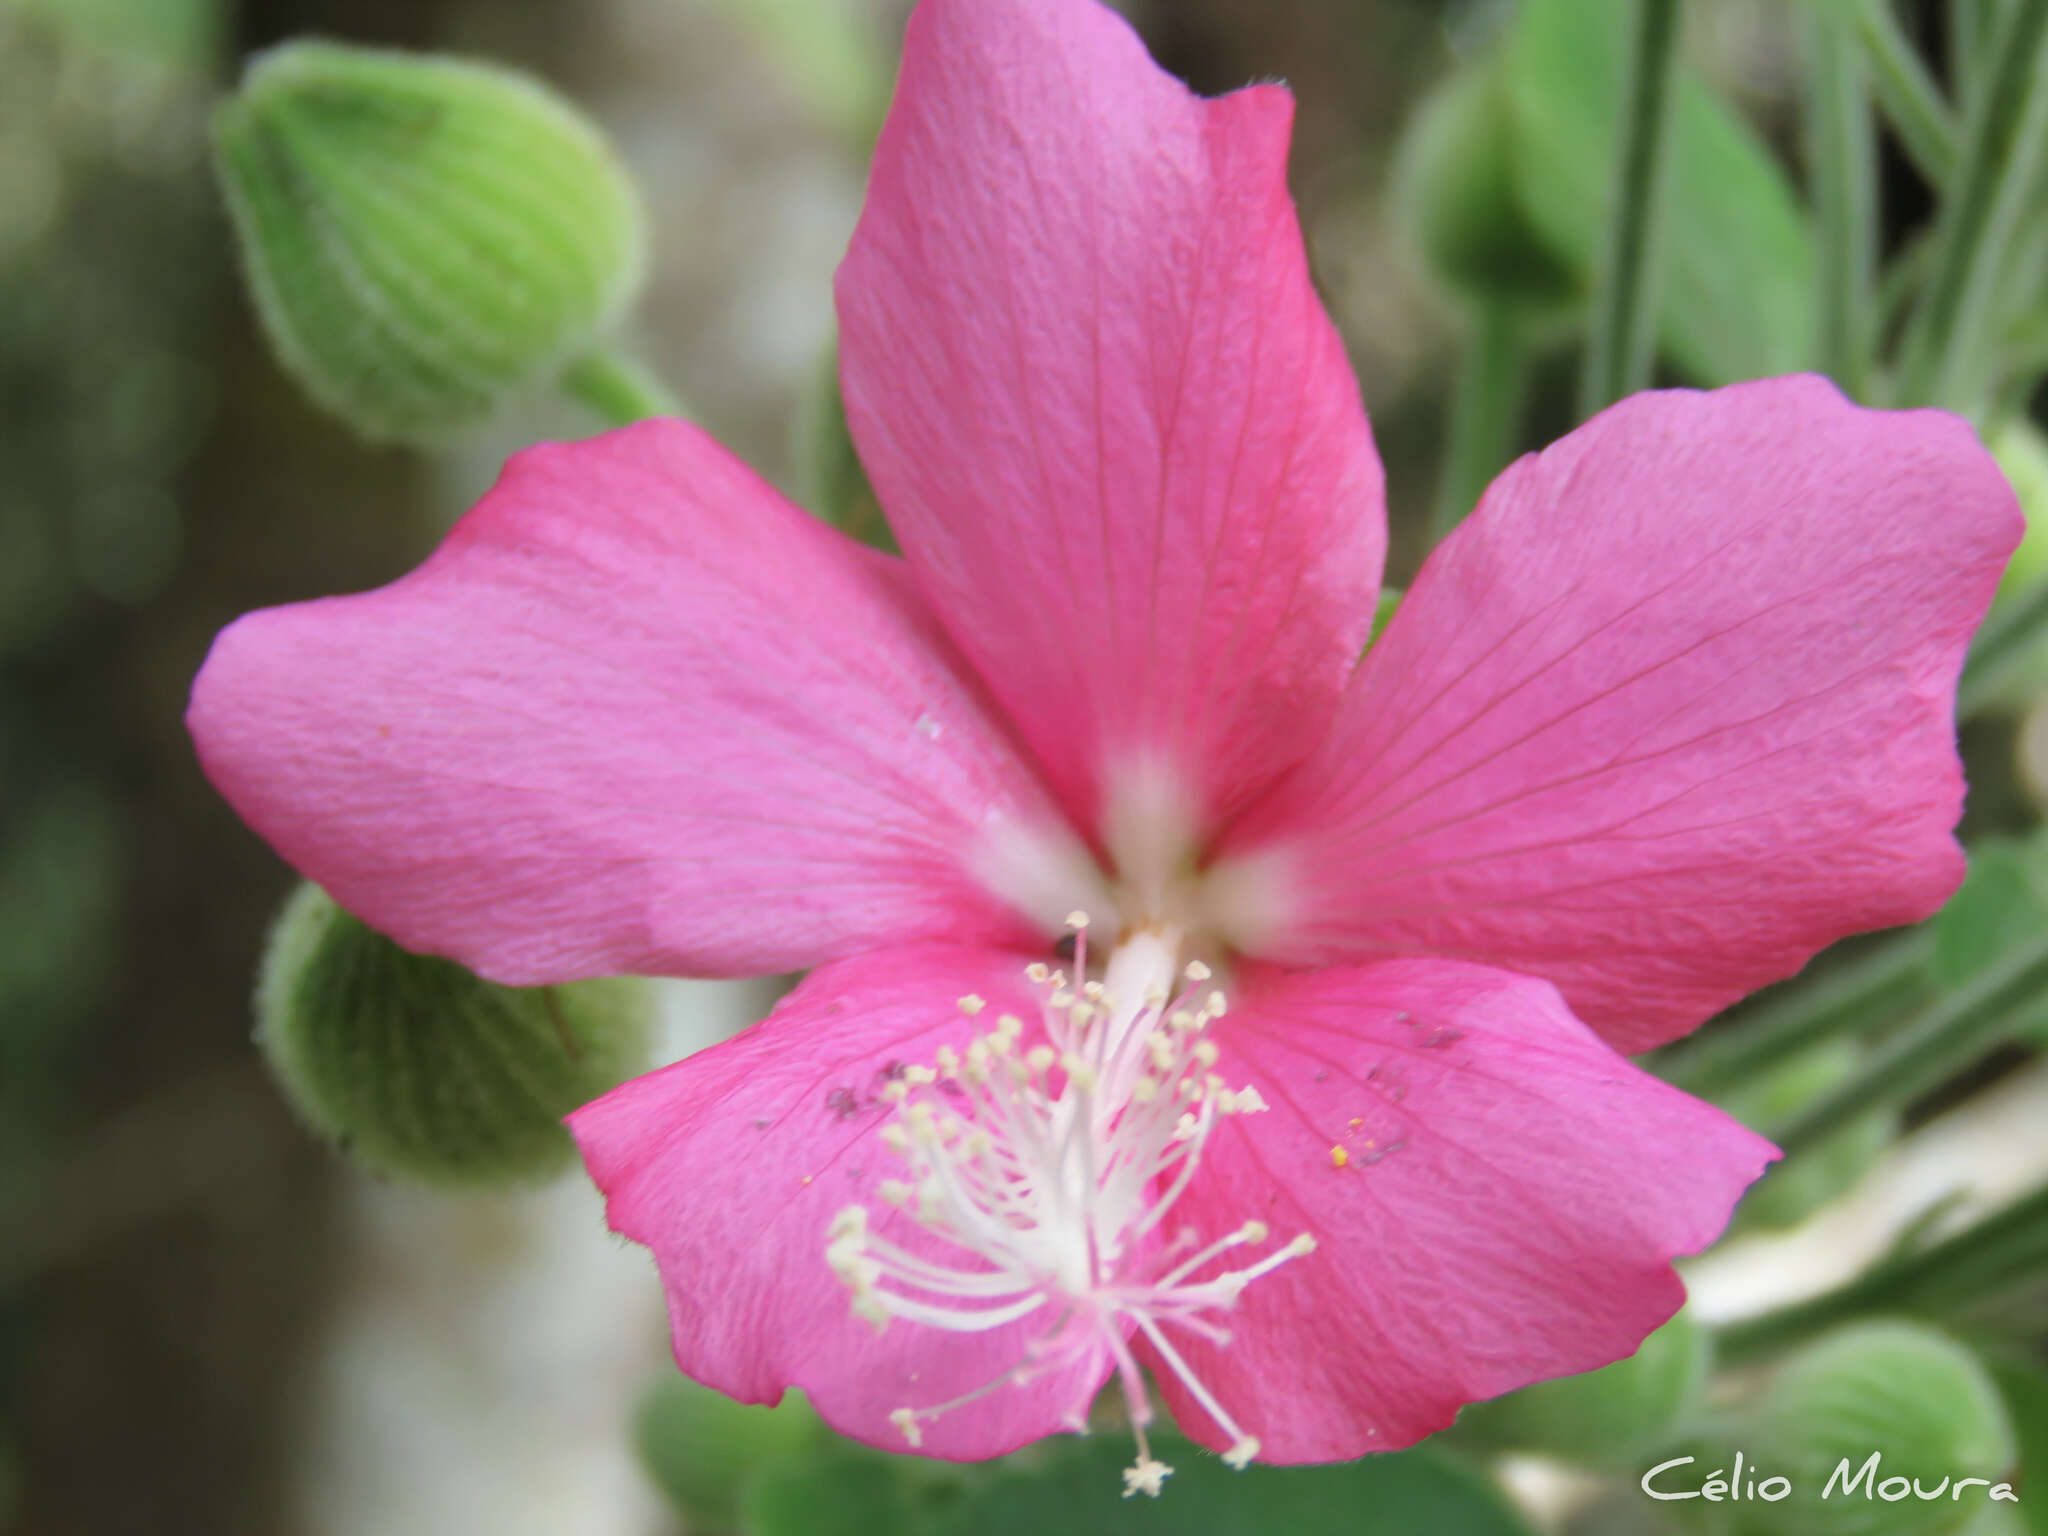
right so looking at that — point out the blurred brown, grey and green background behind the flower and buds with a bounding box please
[0,0,2048,1536]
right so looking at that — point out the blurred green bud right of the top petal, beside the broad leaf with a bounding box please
[1395,68,1583,307]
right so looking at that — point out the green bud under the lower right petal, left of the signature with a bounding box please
[1458,1309,1712,1470]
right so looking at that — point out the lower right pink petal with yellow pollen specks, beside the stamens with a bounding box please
[1153,961,1776,1462]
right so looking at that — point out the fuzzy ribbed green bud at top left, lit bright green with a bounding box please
[213,43,645,442]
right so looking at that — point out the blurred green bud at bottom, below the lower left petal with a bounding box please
[633,1372,831,1530]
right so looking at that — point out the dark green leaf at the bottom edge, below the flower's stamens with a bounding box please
[920,1436,1528,1536]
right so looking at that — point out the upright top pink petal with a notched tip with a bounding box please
[838,0,1384,844]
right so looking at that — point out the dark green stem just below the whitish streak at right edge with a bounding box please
[1714,1188,2048,1364]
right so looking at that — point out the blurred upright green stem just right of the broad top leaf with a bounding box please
[1806,10,1878,399]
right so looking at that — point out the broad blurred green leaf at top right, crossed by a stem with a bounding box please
[1503,0,1815,385]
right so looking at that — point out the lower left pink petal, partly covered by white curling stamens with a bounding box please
[569,948,1110,1460]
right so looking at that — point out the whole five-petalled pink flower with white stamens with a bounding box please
[190,0,2019,1491]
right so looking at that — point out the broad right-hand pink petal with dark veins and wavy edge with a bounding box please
[1231,377,2021,1051]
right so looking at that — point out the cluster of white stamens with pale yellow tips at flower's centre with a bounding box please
[825,913,1315,1497]
